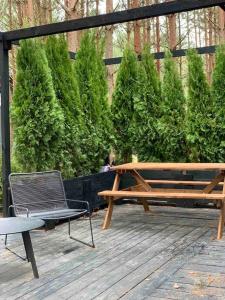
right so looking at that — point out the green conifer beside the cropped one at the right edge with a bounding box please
[186,50,214,162]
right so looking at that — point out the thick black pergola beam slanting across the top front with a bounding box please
[4,0,225,41]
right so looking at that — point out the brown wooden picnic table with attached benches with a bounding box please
[98,162,225,239]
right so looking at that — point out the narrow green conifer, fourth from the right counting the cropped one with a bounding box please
[132,47,163,161]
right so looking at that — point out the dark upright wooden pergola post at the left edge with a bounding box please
[0,35,11,217]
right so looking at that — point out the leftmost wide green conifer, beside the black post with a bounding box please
[11,40,64,172]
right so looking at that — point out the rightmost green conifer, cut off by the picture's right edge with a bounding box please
[212,45,225,162]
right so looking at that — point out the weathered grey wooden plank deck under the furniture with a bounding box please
[0,204,225,300]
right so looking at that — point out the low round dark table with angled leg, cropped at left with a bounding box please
[0,217,45,278]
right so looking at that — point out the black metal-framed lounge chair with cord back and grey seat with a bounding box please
[5,171,95,248]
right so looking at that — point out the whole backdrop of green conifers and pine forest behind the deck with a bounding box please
[0,0,225,178]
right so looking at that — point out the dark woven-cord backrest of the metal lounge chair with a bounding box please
[9,171,68,215]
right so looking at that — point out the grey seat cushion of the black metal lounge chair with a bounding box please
[21,208,87,220]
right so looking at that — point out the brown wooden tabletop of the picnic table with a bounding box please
[111,162,225,171]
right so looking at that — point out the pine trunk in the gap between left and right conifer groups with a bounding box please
[105,0,114,102]
